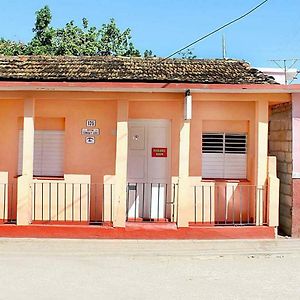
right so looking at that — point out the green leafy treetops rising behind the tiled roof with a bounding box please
[0,6,150,57]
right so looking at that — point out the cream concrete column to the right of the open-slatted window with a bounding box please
[256,99,269,225]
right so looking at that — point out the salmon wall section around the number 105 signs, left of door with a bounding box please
[35,99,117,183]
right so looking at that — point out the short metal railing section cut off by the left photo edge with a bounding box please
[0,183,17,223]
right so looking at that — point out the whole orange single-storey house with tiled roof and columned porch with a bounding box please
[0,56,288,238]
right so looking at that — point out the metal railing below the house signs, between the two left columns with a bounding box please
[31,181,114,224]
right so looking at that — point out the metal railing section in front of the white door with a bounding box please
[126,182,178,222]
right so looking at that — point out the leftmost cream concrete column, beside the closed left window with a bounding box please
[17,99,35,225]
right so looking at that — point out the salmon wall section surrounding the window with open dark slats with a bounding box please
[190,101,256,181]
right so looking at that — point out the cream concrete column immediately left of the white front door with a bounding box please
[113,100,128,227]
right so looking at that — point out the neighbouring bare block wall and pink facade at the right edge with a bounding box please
[269,93,300,237]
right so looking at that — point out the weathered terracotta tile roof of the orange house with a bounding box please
[0,56,275,84]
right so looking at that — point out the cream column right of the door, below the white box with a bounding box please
[177,120,193,227]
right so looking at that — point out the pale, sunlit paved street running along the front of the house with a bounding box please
[0,239,300,300]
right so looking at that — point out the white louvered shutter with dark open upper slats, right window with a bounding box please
[202,133,247,179]
